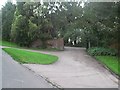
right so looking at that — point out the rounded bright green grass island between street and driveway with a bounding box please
[3,48,58,64]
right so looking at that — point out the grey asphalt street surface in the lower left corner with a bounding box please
[0,49,53,88]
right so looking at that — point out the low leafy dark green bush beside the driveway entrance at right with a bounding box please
[88,47,117,56]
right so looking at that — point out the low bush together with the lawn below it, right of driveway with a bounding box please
[88,47,120,76]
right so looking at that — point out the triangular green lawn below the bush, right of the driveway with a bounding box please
[95,56,120,75]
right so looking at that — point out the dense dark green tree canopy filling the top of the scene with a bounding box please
[2,2,120,48]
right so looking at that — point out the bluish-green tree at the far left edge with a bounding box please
[2,2,15,41]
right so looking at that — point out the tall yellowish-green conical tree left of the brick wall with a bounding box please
[11,2,31,46]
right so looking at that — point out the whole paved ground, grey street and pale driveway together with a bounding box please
[2,47,118,88]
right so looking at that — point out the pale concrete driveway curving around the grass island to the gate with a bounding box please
[24,47,118,88]
